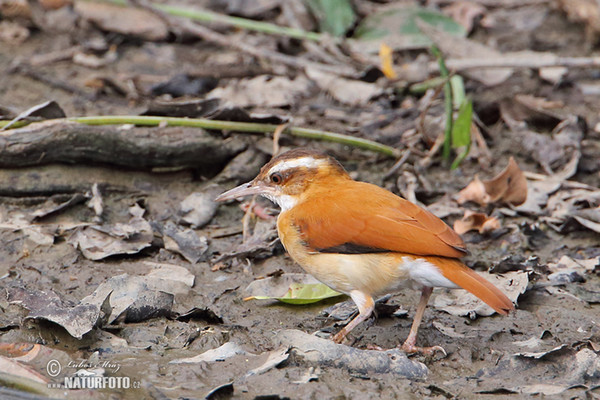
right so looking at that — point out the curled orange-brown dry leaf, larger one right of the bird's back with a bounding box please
[456,157,527,206]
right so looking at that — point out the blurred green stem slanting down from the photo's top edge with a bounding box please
[98,0,322,42]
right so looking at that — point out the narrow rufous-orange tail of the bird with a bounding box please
[428,257,515,315]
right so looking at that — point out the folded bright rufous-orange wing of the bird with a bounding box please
[286,181,467,257]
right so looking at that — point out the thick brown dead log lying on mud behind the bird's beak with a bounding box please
[0,120,246,169]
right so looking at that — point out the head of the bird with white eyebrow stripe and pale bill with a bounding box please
[216,149,351,211]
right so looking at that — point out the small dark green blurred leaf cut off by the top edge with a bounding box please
[307,0,356,37]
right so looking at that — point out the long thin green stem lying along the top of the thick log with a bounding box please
[0,115,400,157]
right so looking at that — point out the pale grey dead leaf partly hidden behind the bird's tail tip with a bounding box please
[433,271,529,317]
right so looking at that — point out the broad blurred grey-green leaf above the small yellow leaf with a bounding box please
[354,6,467,51]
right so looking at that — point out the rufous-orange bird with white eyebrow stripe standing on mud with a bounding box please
[215,148,514,354]
